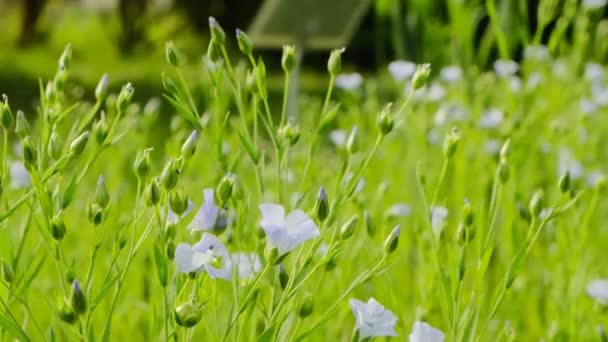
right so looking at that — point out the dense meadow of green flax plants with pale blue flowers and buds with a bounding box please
[0,10,608,342]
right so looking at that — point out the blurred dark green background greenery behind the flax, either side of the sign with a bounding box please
[0,0,608,110]
